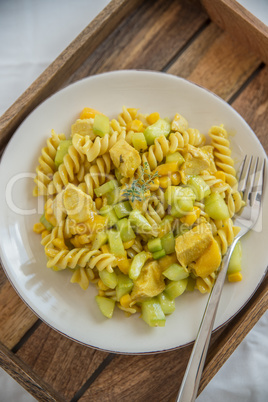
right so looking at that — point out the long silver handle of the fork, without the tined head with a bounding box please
[176,238,238,402]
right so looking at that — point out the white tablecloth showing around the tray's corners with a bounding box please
[0,0,268,402]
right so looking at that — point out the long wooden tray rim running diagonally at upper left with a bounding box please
[0,0,142,153]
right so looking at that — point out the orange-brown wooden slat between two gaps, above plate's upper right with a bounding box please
[168,23,261,101]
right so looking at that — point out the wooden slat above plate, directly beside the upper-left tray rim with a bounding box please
[65,0,208,82]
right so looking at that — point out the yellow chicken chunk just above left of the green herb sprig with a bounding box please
[109,139,141,177]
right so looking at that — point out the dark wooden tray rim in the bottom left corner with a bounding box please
[0,342,64,402]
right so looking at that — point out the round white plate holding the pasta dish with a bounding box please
[0,71,268,353]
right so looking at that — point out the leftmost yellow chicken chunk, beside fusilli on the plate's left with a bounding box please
[63,183,95,223]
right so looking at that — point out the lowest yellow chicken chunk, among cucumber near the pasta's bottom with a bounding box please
[131,261,165,301]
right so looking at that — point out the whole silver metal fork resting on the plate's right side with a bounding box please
[176,156,265,402]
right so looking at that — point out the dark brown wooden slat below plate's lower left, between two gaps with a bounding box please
[16,324,108,400]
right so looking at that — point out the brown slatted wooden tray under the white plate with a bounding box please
[0,0,268,402]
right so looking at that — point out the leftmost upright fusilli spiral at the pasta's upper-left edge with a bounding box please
[33,130,65,196]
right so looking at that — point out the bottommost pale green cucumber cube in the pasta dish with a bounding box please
[141,298,166,327]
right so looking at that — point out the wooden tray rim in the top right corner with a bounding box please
[200,0,268,63]
